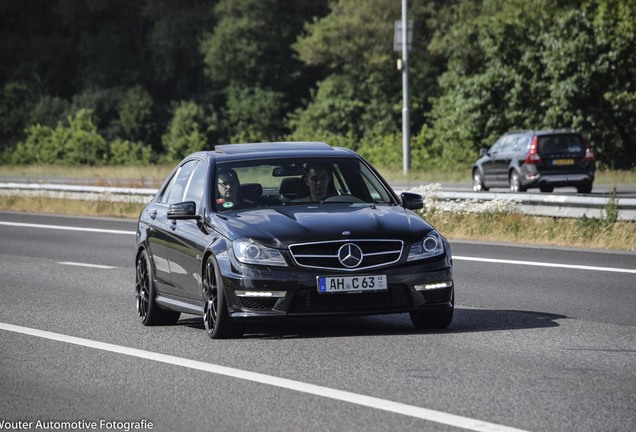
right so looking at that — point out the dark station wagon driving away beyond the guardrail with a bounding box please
[472,130,596,193]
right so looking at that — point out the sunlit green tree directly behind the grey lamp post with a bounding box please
[290,0,444,148]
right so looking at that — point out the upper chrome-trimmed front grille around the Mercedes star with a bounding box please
[289,240,404,271]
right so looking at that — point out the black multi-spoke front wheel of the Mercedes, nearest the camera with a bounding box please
[202,256,243,339]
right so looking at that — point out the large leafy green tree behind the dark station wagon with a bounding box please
[418,0,636,167]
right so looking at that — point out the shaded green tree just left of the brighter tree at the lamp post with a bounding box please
[201,0,326,140]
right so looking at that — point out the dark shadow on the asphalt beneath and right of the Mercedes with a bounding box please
[179,308,567,339]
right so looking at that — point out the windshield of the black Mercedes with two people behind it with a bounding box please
[213,158,396,211]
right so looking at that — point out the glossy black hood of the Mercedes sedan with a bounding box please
[210,204,433,247]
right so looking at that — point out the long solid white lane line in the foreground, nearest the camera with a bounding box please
[0,322,526,432]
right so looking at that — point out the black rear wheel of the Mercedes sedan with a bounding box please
[135,250,181,326]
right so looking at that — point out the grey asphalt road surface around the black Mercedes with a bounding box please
[0,212,636,432]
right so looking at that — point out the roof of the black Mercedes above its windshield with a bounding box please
[191,141,356,161]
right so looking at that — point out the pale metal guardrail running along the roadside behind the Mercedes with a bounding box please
[0,183,636,221]
